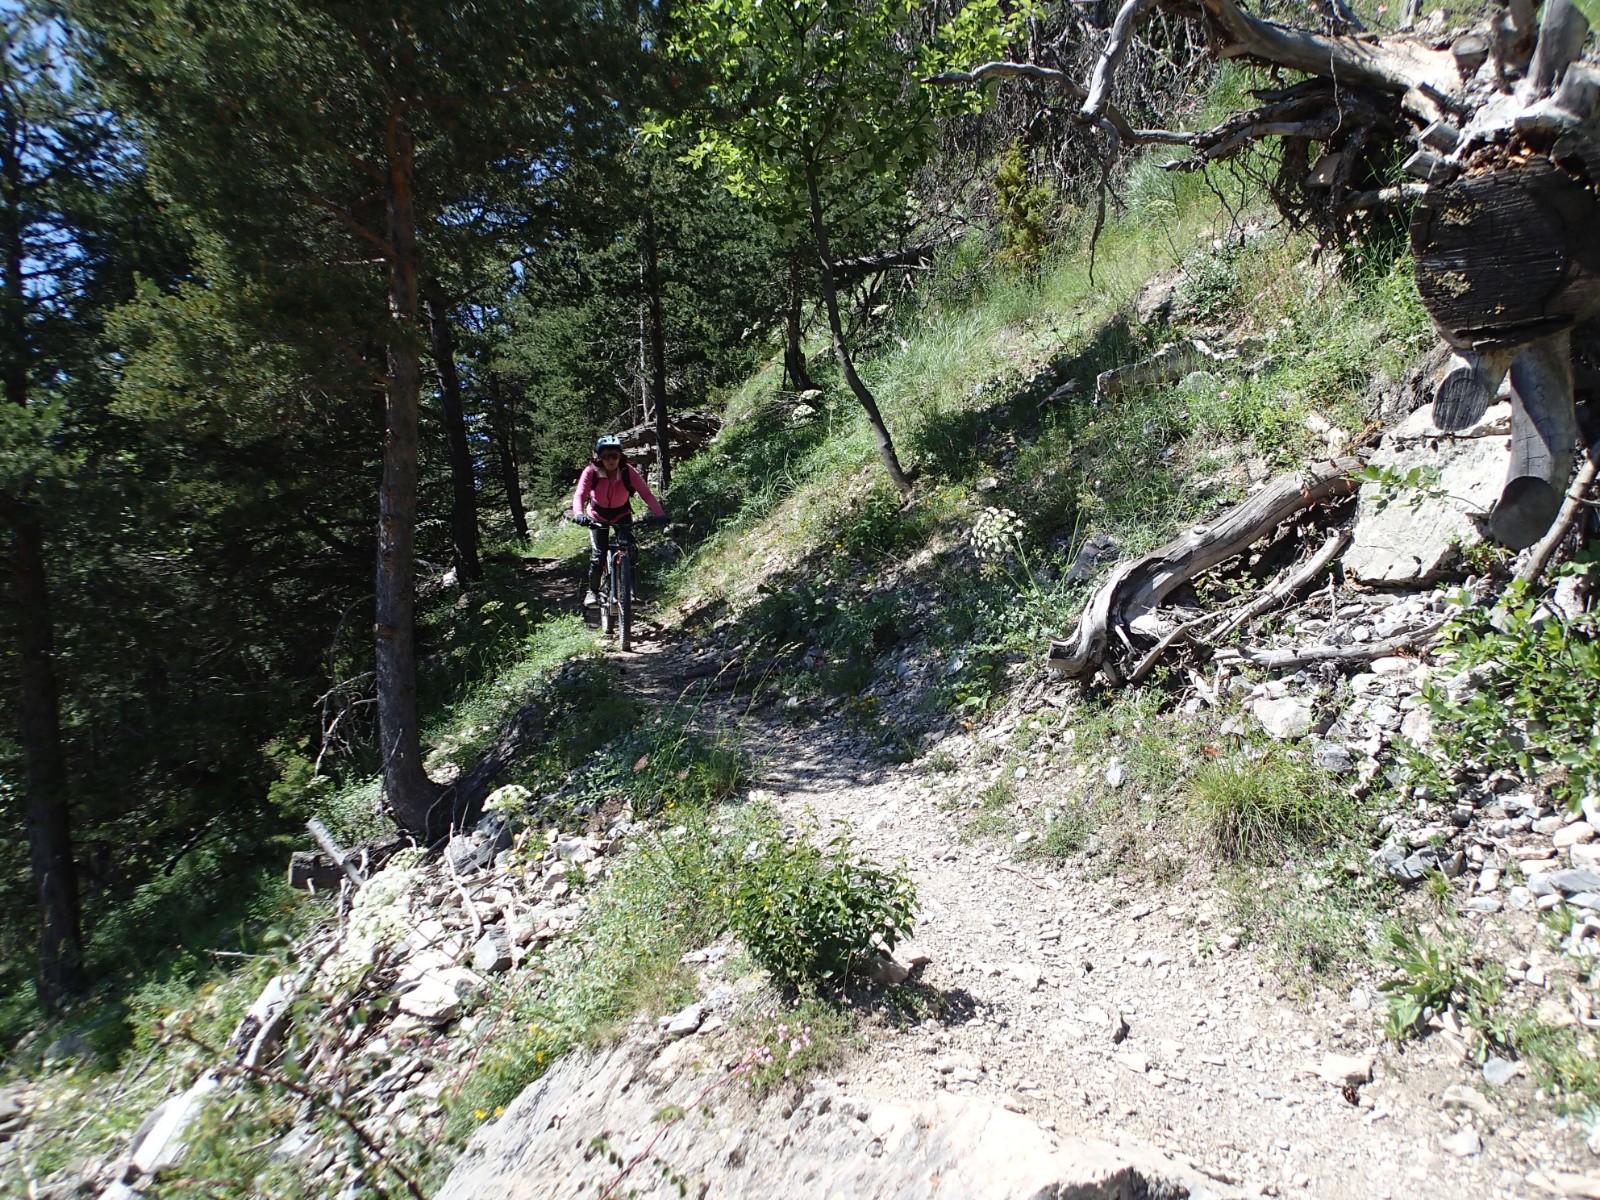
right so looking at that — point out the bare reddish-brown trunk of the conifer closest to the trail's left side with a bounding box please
[376,112,446,842]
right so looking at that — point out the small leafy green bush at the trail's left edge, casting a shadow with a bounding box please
[730,830,917,987]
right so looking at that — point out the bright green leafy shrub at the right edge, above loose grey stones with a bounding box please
[1424,576,1600,805]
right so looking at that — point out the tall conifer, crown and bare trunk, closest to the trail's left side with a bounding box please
[69,0,656,838]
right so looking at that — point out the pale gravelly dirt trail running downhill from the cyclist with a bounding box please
[621,638,1592,1200]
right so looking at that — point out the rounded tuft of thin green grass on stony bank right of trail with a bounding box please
[1184,750,1355,861]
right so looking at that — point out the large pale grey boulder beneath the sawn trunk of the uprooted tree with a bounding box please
[1344,403,1510,584]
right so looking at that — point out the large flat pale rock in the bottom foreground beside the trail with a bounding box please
[435,1038,1234,1200]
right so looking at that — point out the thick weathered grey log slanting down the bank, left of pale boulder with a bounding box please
[1050,458,1362,683]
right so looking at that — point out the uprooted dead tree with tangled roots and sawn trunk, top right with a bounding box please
[934,0,1600,560]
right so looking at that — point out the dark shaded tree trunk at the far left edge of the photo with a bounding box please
[0,103,85,1011]
